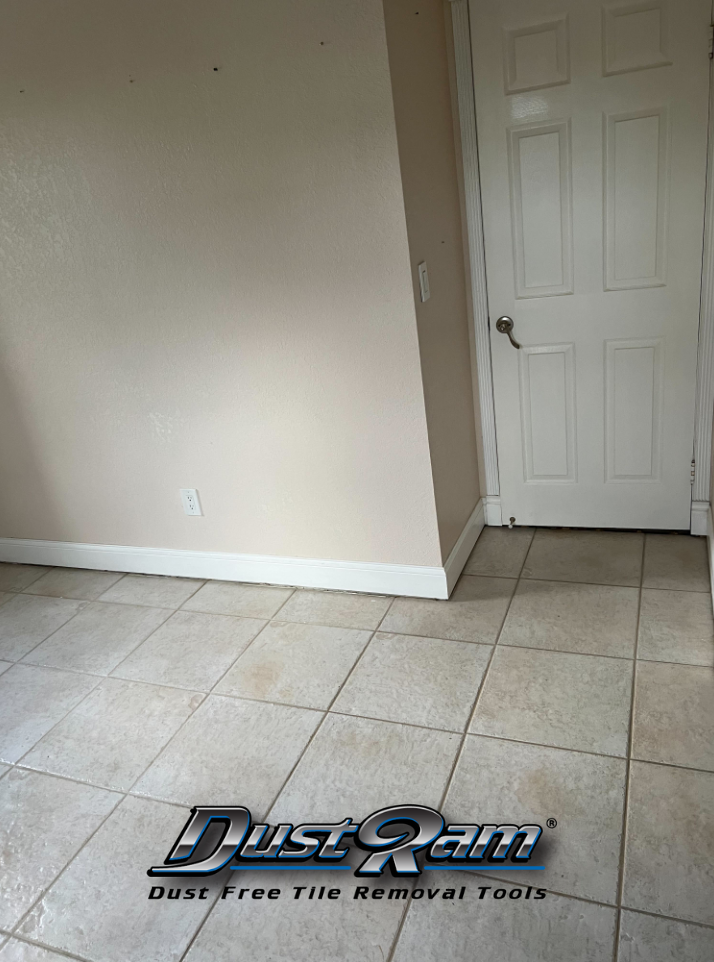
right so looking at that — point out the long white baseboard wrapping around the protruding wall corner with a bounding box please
[0,502,483,598]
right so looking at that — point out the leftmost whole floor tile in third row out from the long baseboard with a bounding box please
[22,678,202,792]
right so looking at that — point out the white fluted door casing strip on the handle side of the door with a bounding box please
[451,0,500,496]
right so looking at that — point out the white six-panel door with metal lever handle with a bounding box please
[471,0,711,529]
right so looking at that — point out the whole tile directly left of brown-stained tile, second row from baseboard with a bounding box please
[112,611,266,691]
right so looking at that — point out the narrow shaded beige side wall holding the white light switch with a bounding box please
[384,0,480,559]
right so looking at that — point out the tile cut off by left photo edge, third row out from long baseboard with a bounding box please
[0,665,99,762]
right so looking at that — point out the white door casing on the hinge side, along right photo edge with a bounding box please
[692,57,714,512]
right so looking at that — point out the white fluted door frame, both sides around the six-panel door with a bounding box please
[450,0,714,535]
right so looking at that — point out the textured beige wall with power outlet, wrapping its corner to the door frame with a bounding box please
[0,0,444,564]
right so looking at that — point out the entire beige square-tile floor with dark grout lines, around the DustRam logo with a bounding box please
[0,528,714,962]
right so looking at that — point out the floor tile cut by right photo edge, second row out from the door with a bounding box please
[637,588,714,666]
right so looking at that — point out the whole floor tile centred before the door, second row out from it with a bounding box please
[500,581,639,658]
